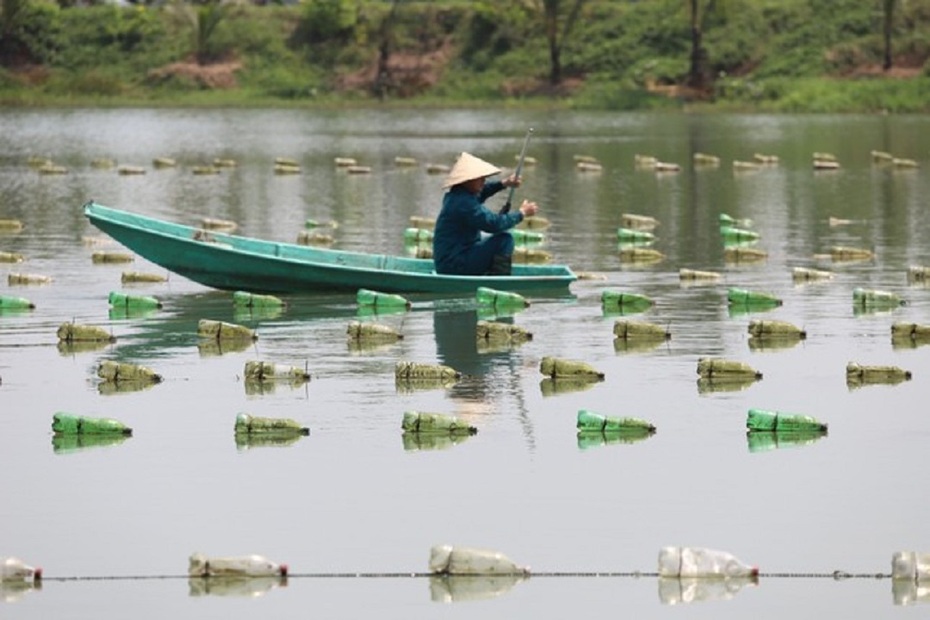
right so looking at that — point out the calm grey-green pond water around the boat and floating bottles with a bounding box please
[0,109,930,619]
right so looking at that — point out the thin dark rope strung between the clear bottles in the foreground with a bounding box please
[36,570,891,582]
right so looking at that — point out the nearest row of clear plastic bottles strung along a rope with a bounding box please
[0,544,930,605]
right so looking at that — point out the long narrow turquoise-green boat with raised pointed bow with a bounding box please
[84,201,577,294]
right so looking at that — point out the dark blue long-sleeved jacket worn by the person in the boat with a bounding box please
[433,181,523,273]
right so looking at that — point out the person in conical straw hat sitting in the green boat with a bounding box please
[433,153,538,275]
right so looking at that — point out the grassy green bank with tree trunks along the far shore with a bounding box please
[0,0,930,113]
